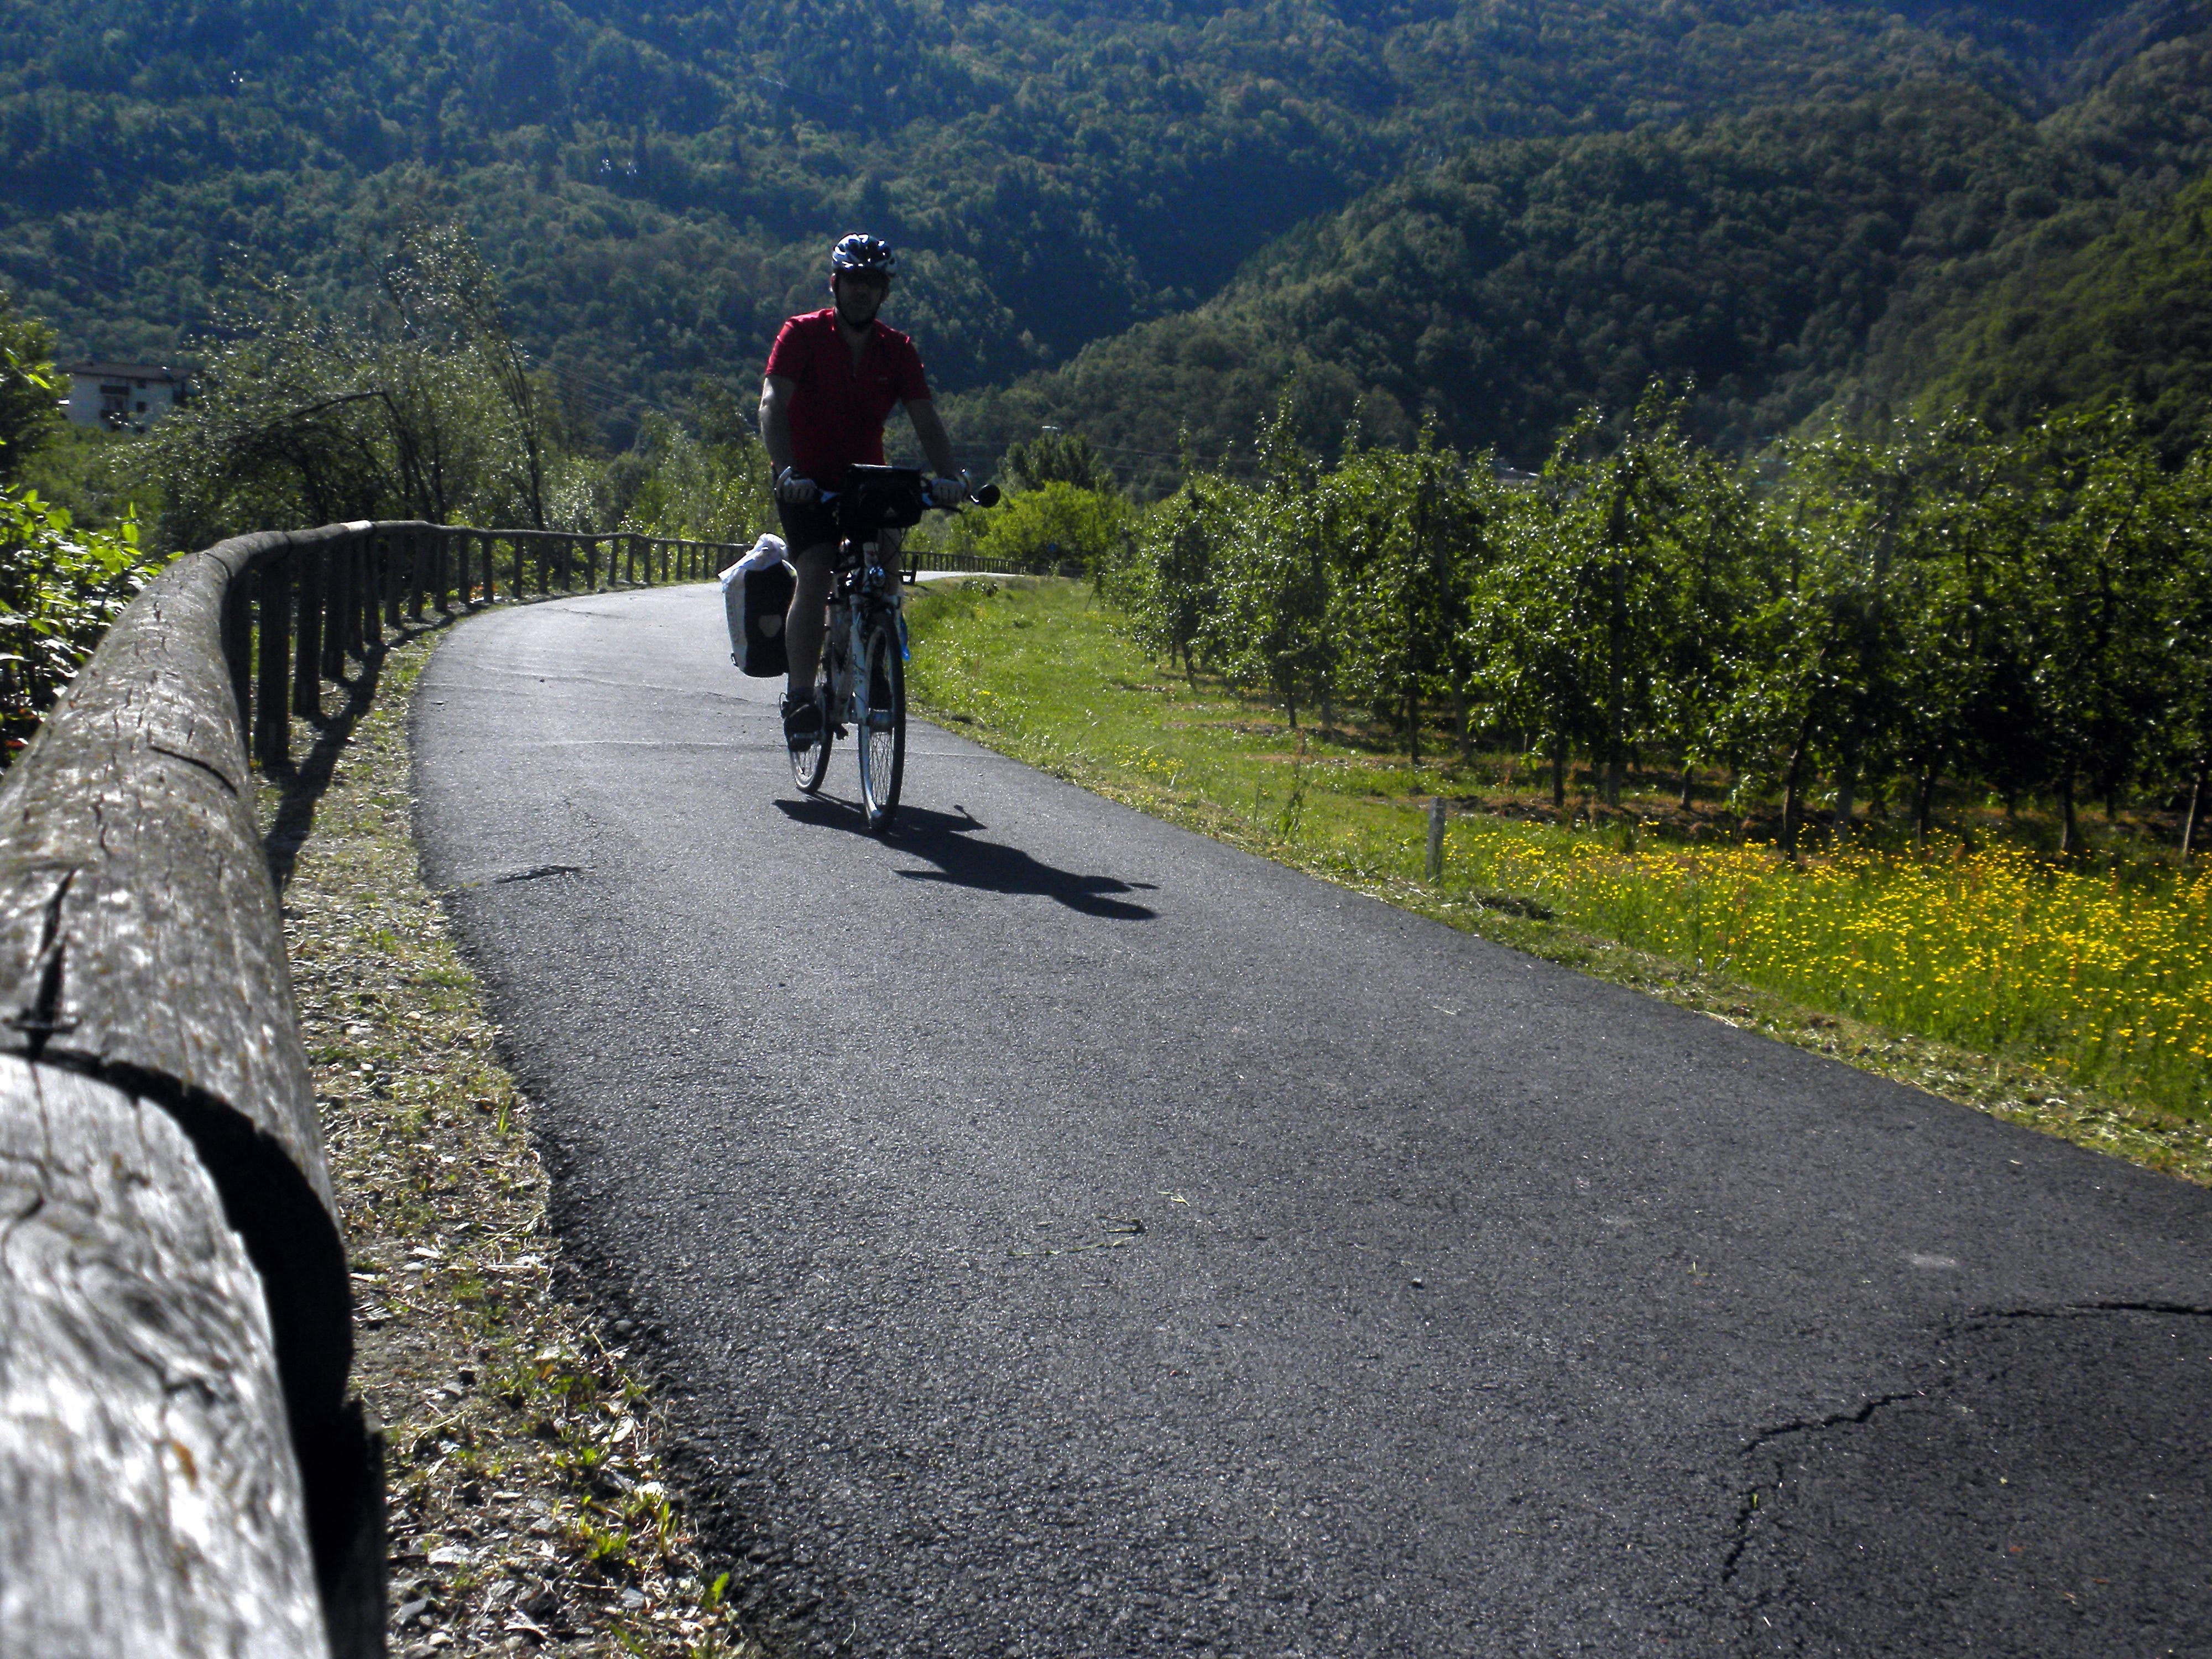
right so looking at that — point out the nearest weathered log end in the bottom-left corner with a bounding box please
[0,1057,325,1659]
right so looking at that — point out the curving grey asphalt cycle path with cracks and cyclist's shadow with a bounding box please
[416,586,2212,1659]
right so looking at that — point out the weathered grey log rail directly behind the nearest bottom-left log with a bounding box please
[0,526,383,1655]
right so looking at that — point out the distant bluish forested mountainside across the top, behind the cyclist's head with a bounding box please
[0,0,2192,447]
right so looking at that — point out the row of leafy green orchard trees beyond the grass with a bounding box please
[1102,387,2212,847]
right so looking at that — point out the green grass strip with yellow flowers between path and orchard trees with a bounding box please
[909,580,2212,1181]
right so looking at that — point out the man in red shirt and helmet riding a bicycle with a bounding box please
[761,232,967,748]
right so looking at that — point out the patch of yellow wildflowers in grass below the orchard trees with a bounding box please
[1447,821,2212,1113]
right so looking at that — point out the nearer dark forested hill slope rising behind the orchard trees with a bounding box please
[967,13,2212,487]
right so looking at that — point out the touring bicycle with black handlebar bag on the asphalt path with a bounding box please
[792,467,998,834]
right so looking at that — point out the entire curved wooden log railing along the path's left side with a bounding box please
[0,522,741,1659]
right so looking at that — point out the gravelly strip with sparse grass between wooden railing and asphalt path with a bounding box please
[261,633,763,1659]
